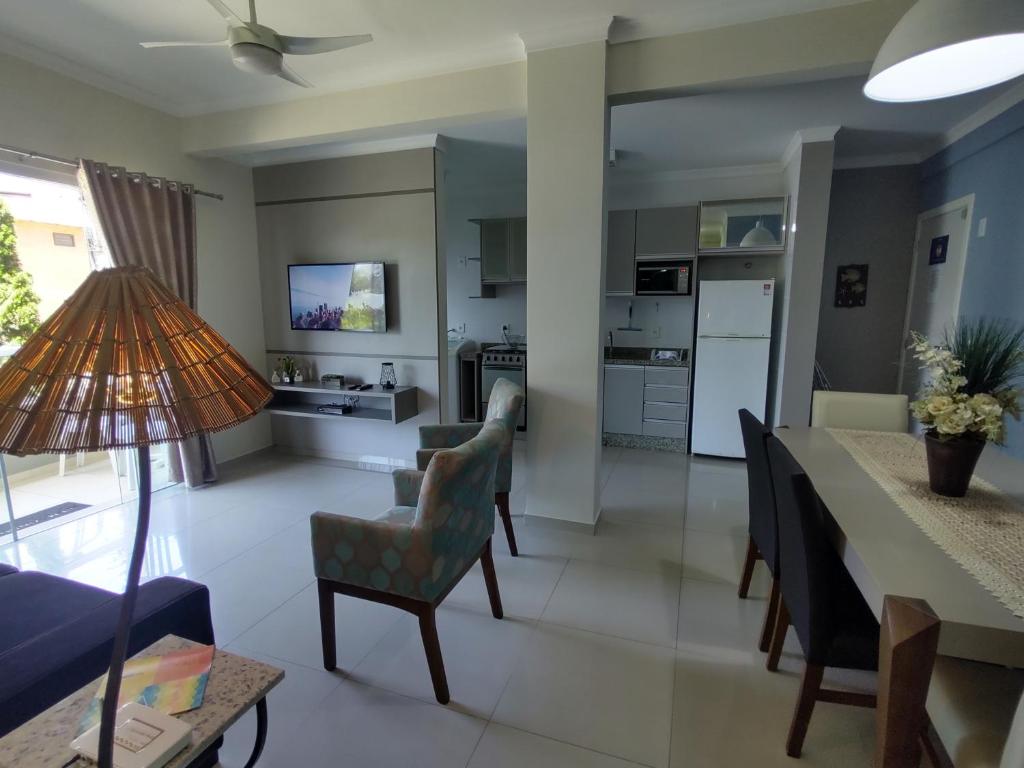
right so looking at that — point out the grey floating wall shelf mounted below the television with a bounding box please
[266,384,419,424]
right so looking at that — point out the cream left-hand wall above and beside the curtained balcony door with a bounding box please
[0,54,270,472]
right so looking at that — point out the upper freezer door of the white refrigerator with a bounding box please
[697,280,775,338]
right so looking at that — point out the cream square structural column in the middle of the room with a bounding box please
[526,36,608,525]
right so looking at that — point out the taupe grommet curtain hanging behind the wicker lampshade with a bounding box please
[79,160,217,487]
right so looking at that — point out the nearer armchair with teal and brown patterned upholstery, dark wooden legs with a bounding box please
[310,420,508,703]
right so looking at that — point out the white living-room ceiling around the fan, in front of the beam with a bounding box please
[0,0,859,115]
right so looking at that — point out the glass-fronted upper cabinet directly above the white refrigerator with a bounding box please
[699,198,786,254]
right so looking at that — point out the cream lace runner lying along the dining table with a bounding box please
[827,429,1024,618]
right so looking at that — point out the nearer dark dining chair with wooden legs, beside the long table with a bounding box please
[768,436,881,758]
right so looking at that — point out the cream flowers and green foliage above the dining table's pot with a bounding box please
[910,318,1024,443]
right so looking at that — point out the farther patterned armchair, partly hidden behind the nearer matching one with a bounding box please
[416,379,526,557]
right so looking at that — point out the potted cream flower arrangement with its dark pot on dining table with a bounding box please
[910,319,1024,498]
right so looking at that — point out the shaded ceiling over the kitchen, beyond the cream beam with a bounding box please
[430,78,1021,181]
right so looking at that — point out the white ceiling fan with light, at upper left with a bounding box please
[140,0,374,88]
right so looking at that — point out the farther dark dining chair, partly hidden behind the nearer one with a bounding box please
[739,409,779,651]
